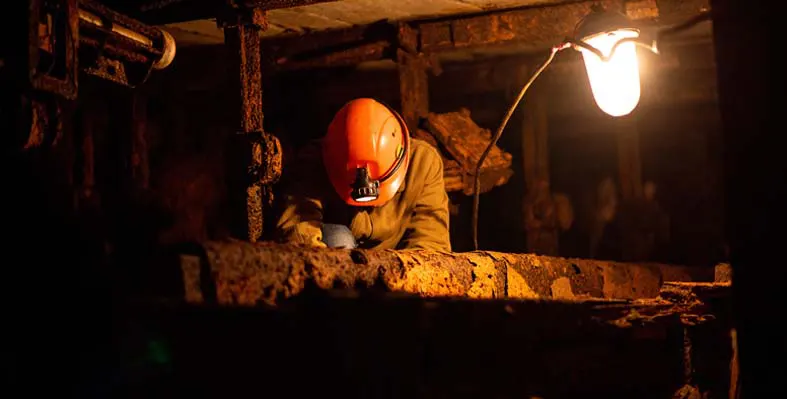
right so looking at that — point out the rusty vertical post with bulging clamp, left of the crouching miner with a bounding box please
[219,9,281,242]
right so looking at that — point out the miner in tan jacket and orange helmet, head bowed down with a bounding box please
[277,98,451,252]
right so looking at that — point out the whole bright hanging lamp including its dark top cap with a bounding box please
[577,10,640,117]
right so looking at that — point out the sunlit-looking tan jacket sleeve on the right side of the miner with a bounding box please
[399,148,451,252]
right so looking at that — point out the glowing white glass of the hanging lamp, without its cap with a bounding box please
[580,29,640,117]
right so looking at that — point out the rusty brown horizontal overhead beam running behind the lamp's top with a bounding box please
[265,0,708,69]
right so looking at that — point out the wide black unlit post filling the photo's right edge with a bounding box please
[711,0,787,398]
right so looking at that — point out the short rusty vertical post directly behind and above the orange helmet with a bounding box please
[396,23,429,134]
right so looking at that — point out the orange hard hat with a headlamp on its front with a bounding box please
[322,98,410,206]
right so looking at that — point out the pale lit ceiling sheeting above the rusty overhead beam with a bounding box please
[167,0,567,45]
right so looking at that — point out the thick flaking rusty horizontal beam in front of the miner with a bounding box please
[181,241,714,305]
